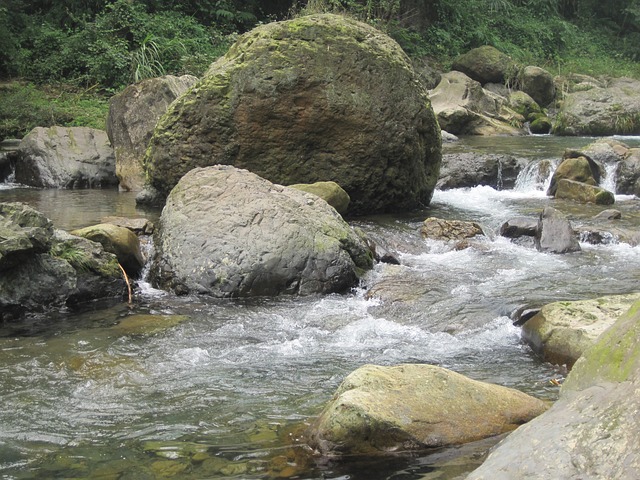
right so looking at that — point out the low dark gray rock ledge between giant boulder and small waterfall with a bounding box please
[436,152,527,190]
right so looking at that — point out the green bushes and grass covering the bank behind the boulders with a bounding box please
[0,0,640,139]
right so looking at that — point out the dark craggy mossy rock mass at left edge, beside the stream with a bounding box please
[0,203,124,321]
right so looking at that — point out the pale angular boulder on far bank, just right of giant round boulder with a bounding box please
[429,71,524,135]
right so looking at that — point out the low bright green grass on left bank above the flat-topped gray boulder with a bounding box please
[0,82,109,140]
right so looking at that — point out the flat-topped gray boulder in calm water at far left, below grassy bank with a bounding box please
[15,127,118,188]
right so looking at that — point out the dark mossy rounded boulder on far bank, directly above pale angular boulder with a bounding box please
[451,45,516,85]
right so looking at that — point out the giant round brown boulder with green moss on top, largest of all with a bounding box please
[145,14,441,214]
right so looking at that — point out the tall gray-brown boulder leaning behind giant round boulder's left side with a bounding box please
[107,75,198,191]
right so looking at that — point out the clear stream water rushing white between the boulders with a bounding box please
[0,137,640,480]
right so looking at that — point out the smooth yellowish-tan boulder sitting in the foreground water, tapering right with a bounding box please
[306,364,547,454]
